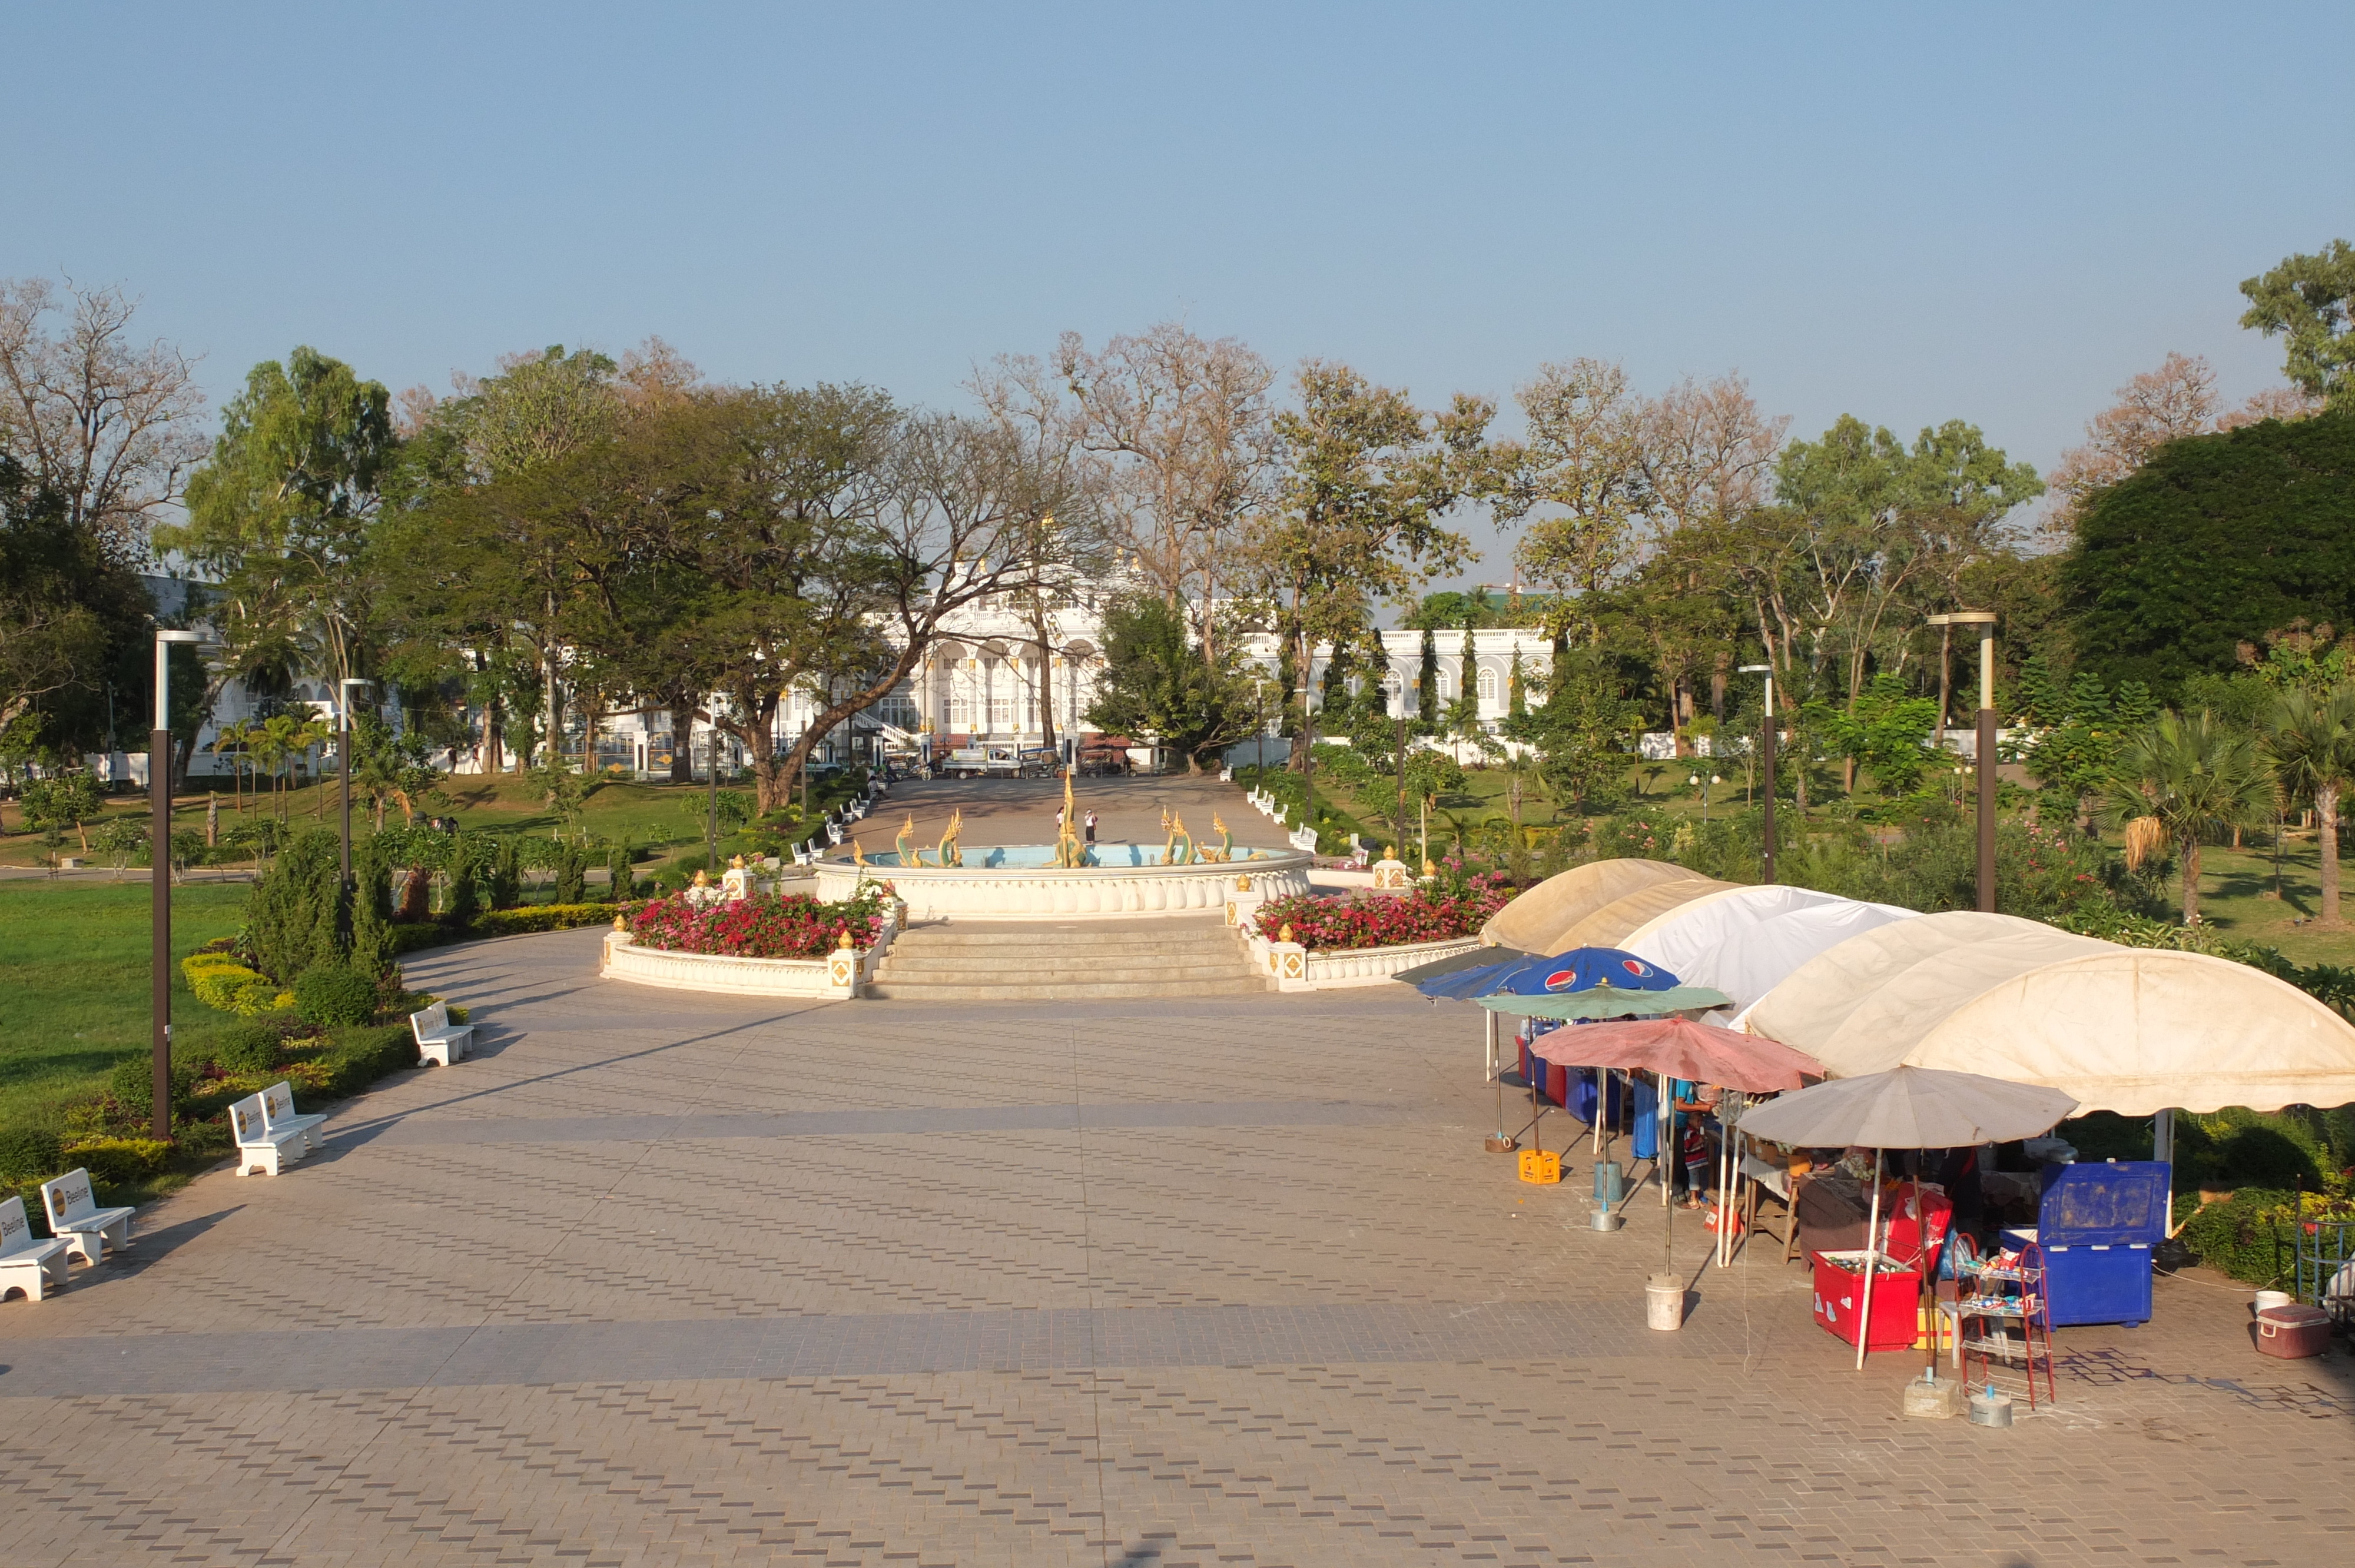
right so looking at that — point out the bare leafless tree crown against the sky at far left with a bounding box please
[0,278,210,553]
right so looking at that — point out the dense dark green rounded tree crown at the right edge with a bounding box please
[2061,412,2355,697]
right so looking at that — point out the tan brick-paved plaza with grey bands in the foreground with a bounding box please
[0,923,2355,1568]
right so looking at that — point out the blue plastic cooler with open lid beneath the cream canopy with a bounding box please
[2004,1161,2171,1328]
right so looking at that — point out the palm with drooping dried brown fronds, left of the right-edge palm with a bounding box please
[2105,709,2273,925]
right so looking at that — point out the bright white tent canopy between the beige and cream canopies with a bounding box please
[1618,883,1922,1008]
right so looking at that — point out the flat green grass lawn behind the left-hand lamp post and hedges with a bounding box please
[0,881,245,1125]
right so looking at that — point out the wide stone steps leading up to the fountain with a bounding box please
[867,918,1276,1001]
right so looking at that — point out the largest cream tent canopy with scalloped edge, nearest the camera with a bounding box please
[1743,911,2355,1116]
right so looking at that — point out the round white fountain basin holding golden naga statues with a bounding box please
[812,843,1309,921]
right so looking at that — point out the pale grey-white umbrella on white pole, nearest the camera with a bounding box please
[1740,1067,2077,1370]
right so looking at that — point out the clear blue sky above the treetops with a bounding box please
[0,0,2355,572]
